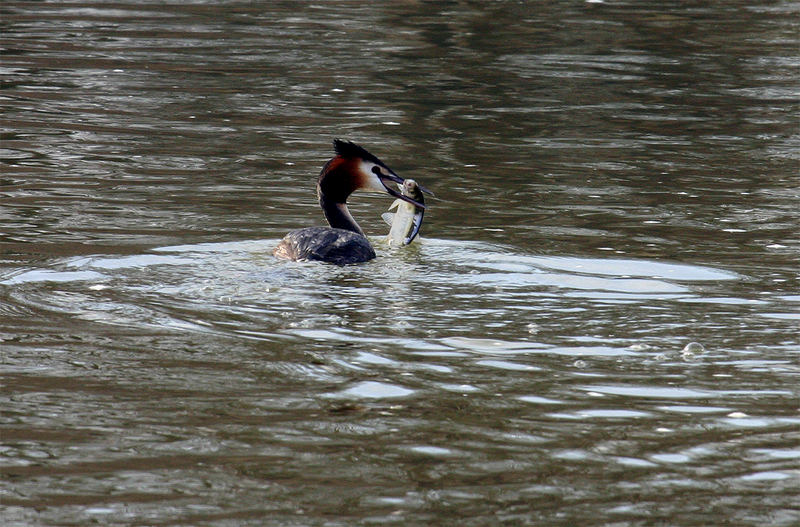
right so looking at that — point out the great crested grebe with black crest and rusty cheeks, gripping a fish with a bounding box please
[273,139,425,265]
